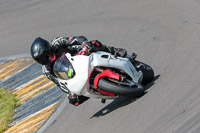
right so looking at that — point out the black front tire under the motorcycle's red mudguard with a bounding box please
[98,78,145,97]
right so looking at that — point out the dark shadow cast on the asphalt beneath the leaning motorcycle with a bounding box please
[90,75,160,119]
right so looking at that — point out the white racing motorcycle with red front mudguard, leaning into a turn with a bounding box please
[53,51,154,103]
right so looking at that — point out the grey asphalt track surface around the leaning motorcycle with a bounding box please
[0,0,200,133]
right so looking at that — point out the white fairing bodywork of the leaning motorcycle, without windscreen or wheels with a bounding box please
[54,51,142,99]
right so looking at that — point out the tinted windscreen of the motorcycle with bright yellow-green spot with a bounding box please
[53,55,75,80]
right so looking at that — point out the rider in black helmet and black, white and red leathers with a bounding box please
[30,36,127,106]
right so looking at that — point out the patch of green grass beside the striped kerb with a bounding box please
[0,89,17,133]
